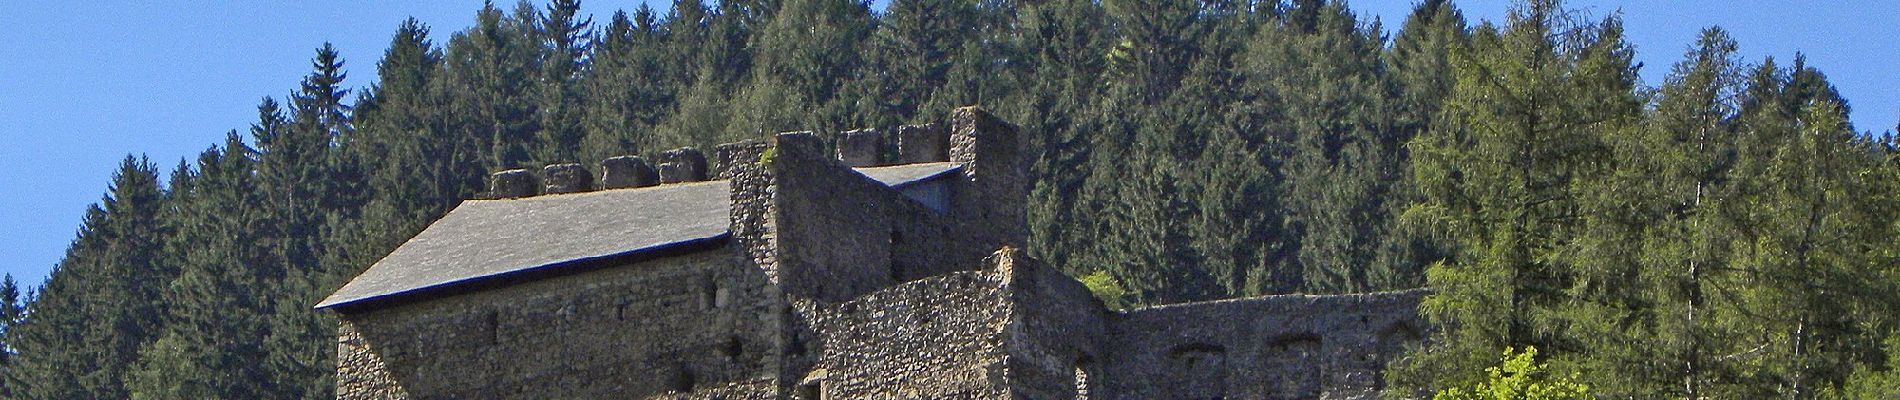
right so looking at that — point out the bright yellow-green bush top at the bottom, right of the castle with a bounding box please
[1431,347,1594,400]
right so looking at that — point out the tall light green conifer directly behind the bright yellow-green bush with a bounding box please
[1398,0,1640,385]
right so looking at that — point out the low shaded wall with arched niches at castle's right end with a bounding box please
[1106,290,1425,400]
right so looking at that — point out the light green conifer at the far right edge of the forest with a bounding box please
[1725,59,1900,398]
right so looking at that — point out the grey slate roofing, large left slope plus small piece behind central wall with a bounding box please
[317,163,958,309]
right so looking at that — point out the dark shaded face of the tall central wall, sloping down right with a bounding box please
[763,133,1020,303]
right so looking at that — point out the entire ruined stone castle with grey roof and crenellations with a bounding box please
[317,108,1425,400]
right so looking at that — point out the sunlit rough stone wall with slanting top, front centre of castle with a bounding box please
[798,271,1009,398]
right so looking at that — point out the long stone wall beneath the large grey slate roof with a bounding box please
[336,250,781,398]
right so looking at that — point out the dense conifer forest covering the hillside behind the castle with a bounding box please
[0,0,1900,398]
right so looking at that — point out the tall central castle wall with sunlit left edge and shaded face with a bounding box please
[718,127,1033,394]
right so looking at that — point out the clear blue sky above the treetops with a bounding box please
[0,0,1900,284]
